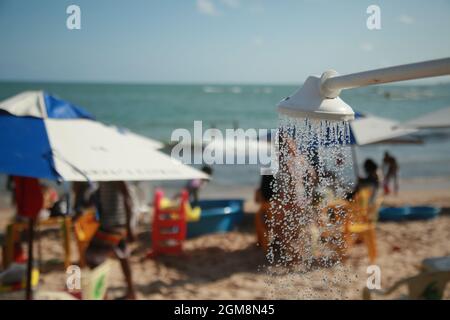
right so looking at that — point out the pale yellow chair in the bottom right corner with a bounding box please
[363,271,450,300]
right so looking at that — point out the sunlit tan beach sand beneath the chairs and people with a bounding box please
[0,181,450,299]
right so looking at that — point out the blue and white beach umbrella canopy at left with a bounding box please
[0,91,207,181]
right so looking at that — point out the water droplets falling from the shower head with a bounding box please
[267,116,352,299]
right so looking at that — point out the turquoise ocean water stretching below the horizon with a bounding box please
[0,82,450,192]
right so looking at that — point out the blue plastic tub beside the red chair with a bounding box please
[187,199,244,238]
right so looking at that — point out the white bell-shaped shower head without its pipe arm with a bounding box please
[278,70,355,121]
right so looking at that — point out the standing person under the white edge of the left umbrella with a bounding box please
[86,181,136,300]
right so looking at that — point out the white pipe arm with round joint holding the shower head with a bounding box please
[320,58,450,98]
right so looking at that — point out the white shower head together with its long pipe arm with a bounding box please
[278,58,450,121]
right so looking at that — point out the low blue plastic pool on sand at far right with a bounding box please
[379,206,441,221]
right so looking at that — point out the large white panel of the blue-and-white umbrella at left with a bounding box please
[46,119,207,181]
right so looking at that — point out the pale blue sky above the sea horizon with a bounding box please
[0,0,450,83]
